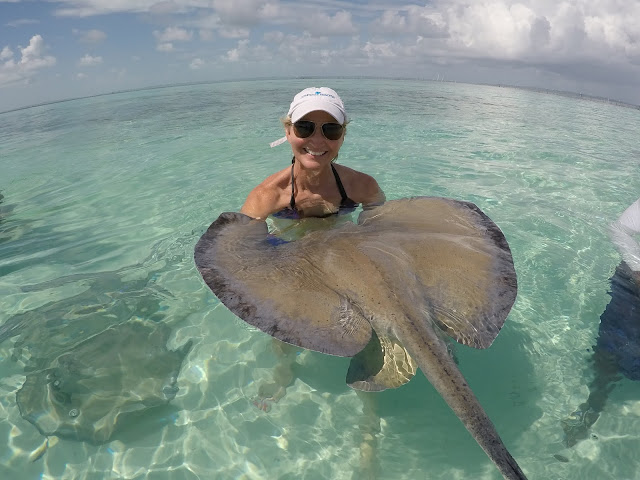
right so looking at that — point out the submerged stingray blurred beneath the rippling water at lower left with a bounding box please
[16,320,191,444]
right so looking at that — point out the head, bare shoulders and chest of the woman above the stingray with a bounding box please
[240,87,385,219]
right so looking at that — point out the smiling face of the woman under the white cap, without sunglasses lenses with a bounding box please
[286,110,344,169]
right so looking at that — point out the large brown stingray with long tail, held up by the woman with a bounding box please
[195,197,526,479]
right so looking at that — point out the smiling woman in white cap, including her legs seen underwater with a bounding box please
[240,87,385,478]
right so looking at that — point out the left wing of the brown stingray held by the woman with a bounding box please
[195,212,371,357]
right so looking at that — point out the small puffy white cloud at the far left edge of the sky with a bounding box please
[0,35,56,86]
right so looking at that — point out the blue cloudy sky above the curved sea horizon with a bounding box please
[0,0,640,112]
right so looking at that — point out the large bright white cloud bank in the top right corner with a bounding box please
[436,0,640,62]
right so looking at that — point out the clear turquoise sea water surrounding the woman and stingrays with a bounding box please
[0,79,640,480]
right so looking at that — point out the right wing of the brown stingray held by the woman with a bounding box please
[358,197,517,348]
